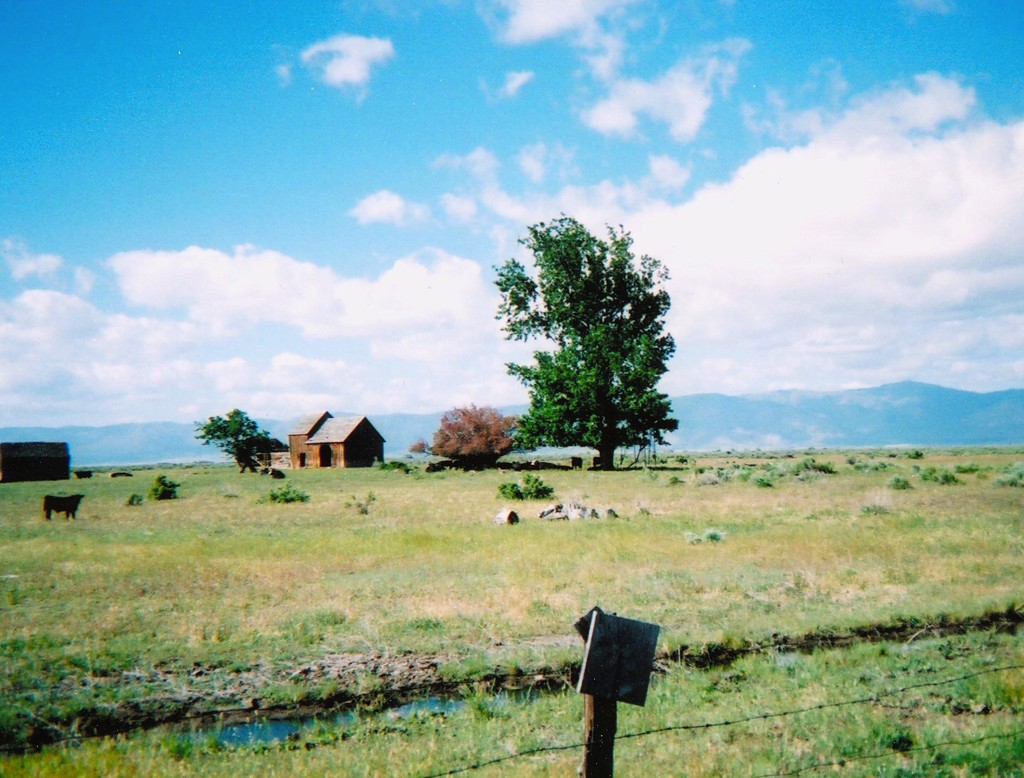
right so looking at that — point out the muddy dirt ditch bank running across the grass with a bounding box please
[9,607,1024,750]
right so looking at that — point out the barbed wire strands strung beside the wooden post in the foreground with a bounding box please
[420,664,1024,778]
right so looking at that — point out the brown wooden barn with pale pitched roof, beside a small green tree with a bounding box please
[288,410,384,468]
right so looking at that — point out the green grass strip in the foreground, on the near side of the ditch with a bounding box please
[4,633,1024,778]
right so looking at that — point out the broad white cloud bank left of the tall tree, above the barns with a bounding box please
[0,247,522,425]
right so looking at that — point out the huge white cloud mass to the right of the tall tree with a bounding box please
[626,76,1024,391]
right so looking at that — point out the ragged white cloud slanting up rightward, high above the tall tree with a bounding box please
[582,39,751,142]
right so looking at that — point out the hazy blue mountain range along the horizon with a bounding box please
[0,382,1024,467]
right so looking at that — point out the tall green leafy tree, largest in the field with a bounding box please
[496,216,679,470]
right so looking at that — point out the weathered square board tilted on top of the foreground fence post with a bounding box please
[575,607,660,705]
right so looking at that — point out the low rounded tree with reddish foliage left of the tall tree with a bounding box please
[430,405,516,467]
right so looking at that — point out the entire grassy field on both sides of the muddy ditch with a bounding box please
[0,449,1024,775]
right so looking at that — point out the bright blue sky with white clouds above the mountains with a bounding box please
[0,0,1024,426]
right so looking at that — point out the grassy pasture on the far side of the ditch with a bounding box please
[0,449,1024,774]
